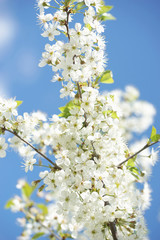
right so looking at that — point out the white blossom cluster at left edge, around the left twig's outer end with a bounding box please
[0,95,46,172]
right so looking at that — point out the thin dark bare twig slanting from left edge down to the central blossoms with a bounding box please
[4,128,61,170]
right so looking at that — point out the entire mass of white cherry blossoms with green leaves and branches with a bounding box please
[0,0,159,240]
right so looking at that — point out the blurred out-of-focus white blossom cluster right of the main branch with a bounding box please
[104,86,156,140]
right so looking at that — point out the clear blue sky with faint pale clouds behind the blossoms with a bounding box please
[0,0,160,240]
